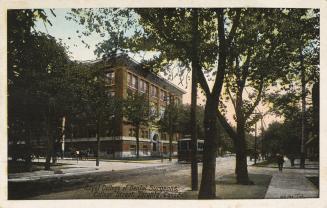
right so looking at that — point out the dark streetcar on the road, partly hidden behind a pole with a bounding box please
[177,138,204,162]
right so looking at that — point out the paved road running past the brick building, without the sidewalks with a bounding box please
[19,157,241,199]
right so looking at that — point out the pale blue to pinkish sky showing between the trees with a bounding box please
[35,9,281,132]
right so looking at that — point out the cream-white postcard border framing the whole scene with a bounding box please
[0,0,327,208]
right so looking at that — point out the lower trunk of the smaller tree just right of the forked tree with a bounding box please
[235,124,253,185]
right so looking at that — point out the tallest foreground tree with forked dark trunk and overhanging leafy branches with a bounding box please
[68,9,239,198]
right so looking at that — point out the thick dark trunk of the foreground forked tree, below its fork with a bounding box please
[199,97,218,199]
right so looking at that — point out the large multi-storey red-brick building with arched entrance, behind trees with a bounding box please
[62,56,185,158]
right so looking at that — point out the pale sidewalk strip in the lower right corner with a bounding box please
[265,160,319,199]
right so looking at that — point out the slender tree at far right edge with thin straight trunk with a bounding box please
[266,9,320,168]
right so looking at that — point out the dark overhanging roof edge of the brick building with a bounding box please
[82,54,186,95]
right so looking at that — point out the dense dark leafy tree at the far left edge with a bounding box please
[8,9,69,169]
